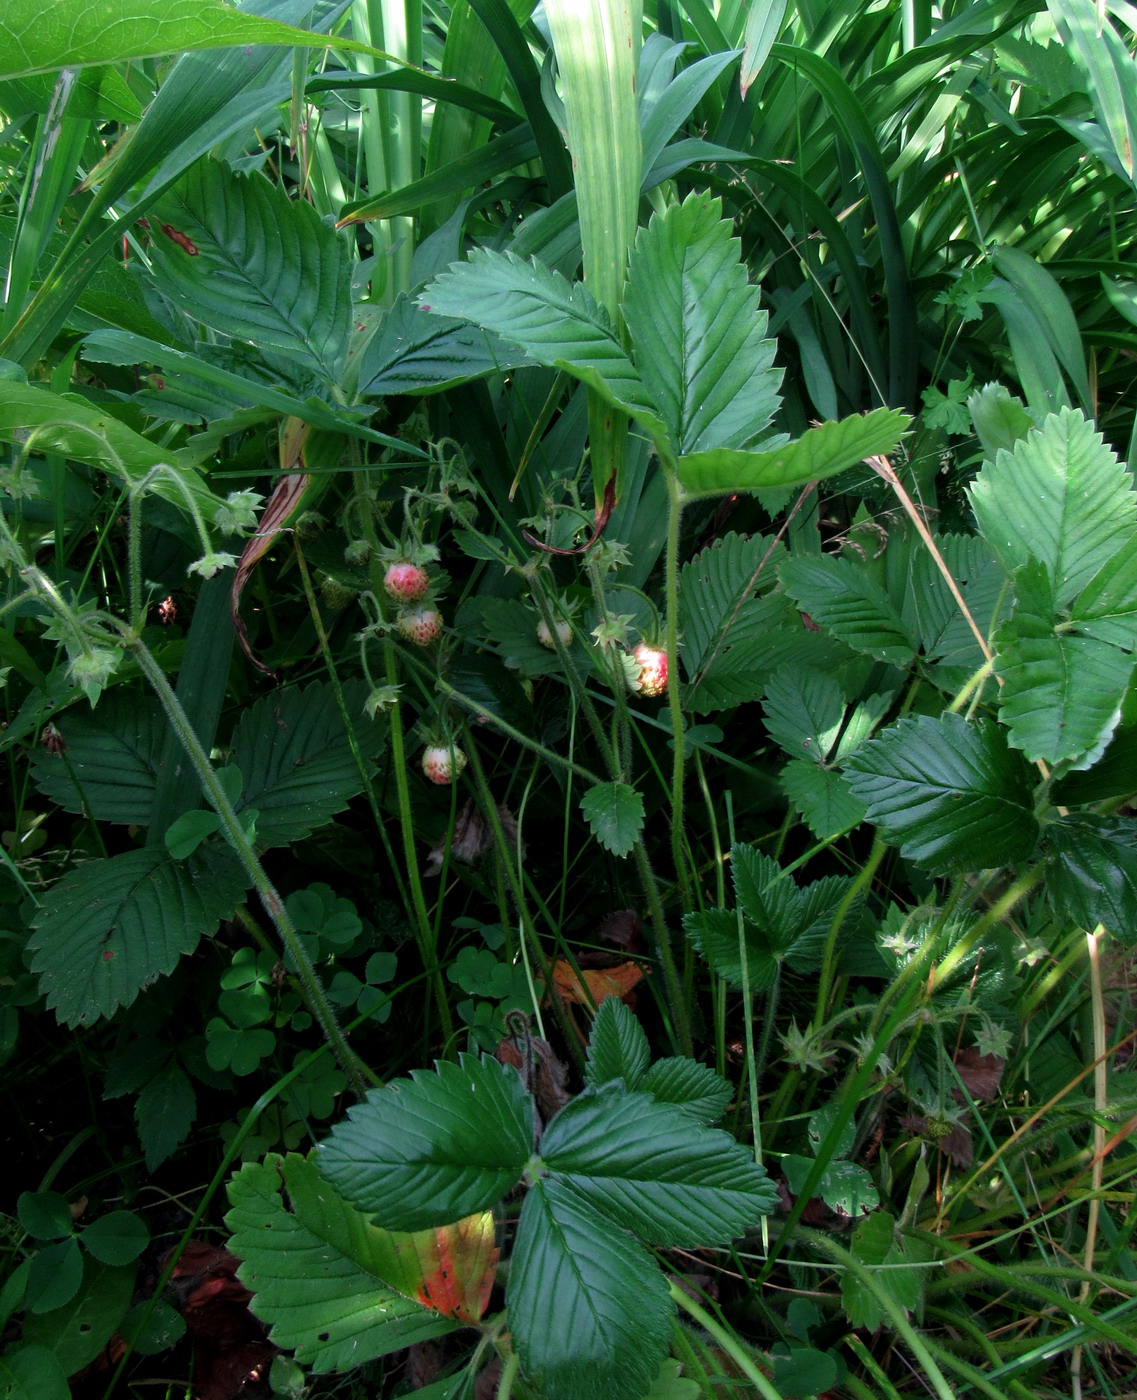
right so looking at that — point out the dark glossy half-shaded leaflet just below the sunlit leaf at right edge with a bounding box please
[846,714,1038,874]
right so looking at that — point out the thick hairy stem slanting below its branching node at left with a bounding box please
[126,636,378,1098]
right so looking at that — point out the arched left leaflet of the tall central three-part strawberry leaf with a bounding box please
[420,248,665,434]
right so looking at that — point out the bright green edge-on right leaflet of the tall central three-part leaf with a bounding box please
[678,409,910,498]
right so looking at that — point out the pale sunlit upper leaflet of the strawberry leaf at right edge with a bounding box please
[970,409,1137,606]
